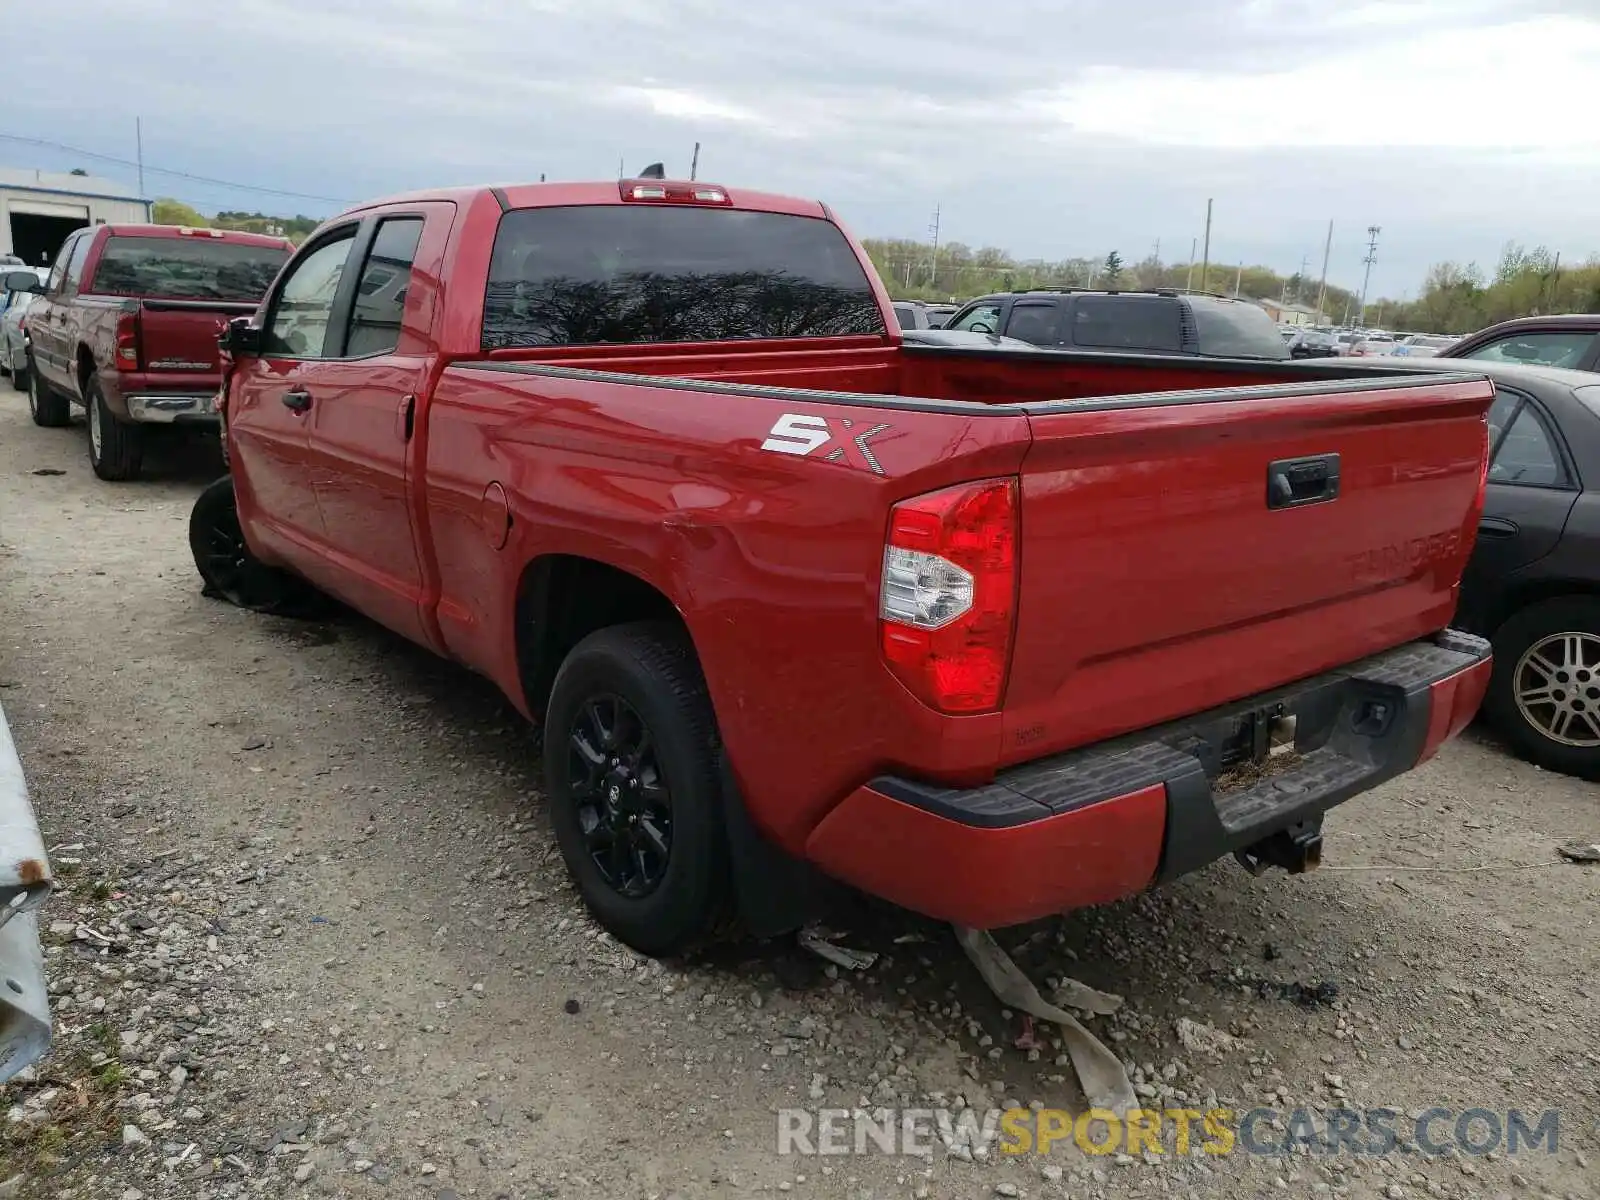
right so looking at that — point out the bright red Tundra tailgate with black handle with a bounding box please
[1003,374,1493,762]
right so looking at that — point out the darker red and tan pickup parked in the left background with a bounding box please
[24,226,294,480]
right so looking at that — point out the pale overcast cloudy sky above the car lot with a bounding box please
[0,0,1600,296]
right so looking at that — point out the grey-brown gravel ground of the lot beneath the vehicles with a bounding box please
[0,392,1600,1200]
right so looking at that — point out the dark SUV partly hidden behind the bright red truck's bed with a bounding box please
[944,288,1290,358]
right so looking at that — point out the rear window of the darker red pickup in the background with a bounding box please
[90,237,290,301]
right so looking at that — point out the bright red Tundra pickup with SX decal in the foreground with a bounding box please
[190,179,1493,954]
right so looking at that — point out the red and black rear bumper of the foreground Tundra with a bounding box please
[806,630,1491,928]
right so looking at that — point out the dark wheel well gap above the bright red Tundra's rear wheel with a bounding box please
[517,554,682,715]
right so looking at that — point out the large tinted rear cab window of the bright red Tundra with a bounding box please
[483,205,886,350]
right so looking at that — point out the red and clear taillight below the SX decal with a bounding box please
[878,478,1018,712]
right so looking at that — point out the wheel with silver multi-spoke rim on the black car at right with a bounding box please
[1485,595,1600,781]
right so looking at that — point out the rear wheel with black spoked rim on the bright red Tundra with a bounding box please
[544,622,728,957]
